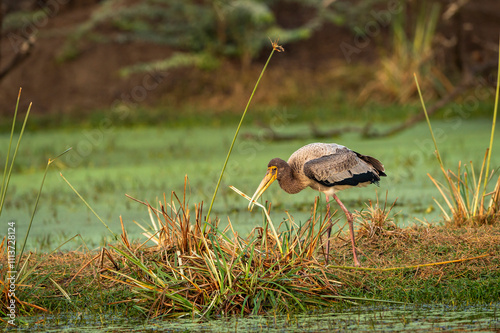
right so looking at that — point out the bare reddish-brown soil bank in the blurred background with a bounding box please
[0,0,500,116]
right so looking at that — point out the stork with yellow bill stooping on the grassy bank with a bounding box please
[248,143,386,266]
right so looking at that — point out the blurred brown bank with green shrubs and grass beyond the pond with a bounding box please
[0,0,500,128]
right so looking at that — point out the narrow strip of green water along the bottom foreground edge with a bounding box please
[10,303,500,333]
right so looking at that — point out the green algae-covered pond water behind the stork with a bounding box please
[0,119,500,251]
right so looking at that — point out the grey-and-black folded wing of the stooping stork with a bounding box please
[303,148,385,186]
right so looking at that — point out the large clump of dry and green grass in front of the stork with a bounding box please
[102,182,342,318]
